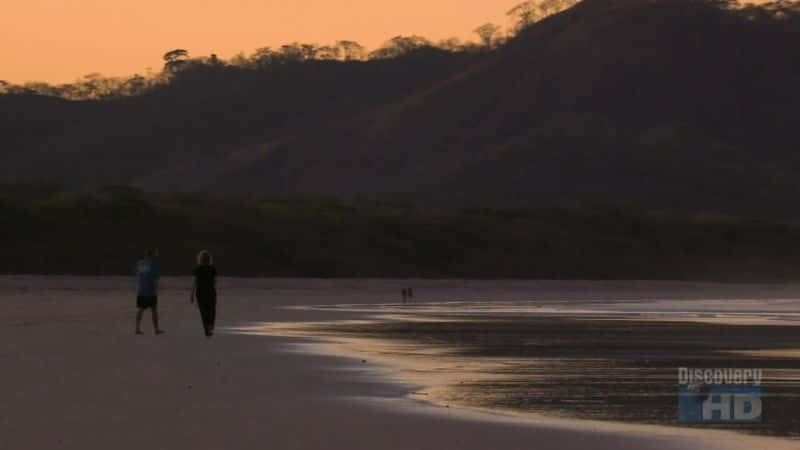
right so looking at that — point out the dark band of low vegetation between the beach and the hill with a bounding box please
[0,185,800,282]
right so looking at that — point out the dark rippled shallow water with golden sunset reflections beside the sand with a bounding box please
[242,300,800,438]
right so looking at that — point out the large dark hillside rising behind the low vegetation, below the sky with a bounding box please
[0,0,800,216]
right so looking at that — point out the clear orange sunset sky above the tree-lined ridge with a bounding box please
[0,0,519,83]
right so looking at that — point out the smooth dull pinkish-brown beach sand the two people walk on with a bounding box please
[0,277,800,450]
